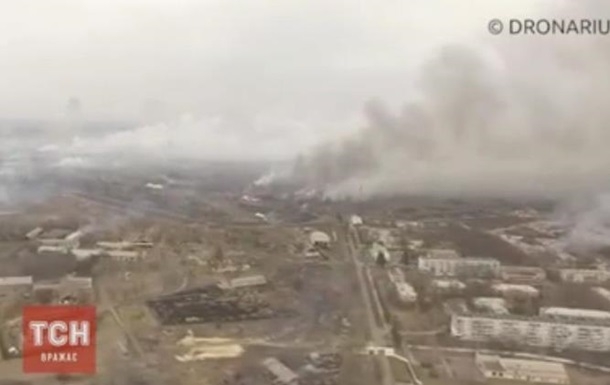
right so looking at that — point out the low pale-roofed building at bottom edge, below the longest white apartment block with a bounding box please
[475,354,570,385]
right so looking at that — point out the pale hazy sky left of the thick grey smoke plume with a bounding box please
[0,0,541,122]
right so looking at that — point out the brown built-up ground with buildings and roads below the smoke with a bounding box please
[0,166,610,385]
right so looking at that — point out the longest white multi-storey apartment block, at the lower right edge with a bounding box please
[451,314,610,352]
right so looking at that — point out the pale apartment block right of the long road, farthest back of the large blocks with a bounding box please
[417,257,500,277]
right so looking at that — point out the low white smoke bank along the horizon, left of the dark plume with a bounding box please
[60,115,352,165]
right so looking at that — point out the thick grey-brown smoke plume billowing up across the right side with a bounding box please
[295,1,610,198]
